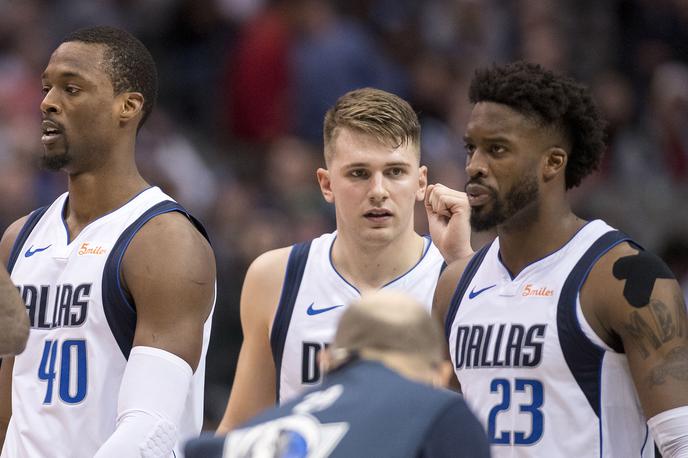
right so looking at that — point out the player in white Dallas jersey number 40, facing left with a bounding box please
[0,27,215,458]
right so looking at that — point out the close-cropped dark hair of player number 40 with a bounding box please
[62,26,158,128]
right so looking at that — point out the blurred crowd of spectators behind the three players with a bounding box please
[0,0,688,428]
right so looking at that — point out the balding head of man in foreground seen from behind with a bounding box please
[329,291,444,381]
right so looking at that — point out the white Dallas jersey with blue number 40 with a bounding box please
[2,188,211,458]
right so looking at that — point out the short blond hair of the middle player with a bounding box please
[323,87,420,163]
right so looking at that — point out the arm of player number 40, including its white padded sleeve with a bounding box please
[96,212,215,458]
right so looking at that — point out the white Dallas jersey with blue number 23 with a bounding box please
[446,220,654,458]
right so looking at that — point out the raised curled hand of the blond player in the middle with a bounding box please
[425,184,473,264]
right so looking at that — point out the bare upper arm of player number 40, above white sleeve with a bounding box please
[121,212,215,371]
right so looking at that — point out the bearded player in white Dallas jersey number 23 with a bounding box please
[434,62,688,457]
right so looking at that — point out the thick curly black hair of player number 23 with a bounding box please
[469,61,606,189]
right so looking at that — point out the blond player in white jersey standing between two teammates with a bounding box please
[218,88,472,432]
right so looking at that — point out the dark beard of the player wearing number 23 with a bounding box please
[470,175,540,232]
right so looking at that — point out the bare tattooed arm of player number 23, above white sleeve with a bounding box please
[581,244,688,418]
